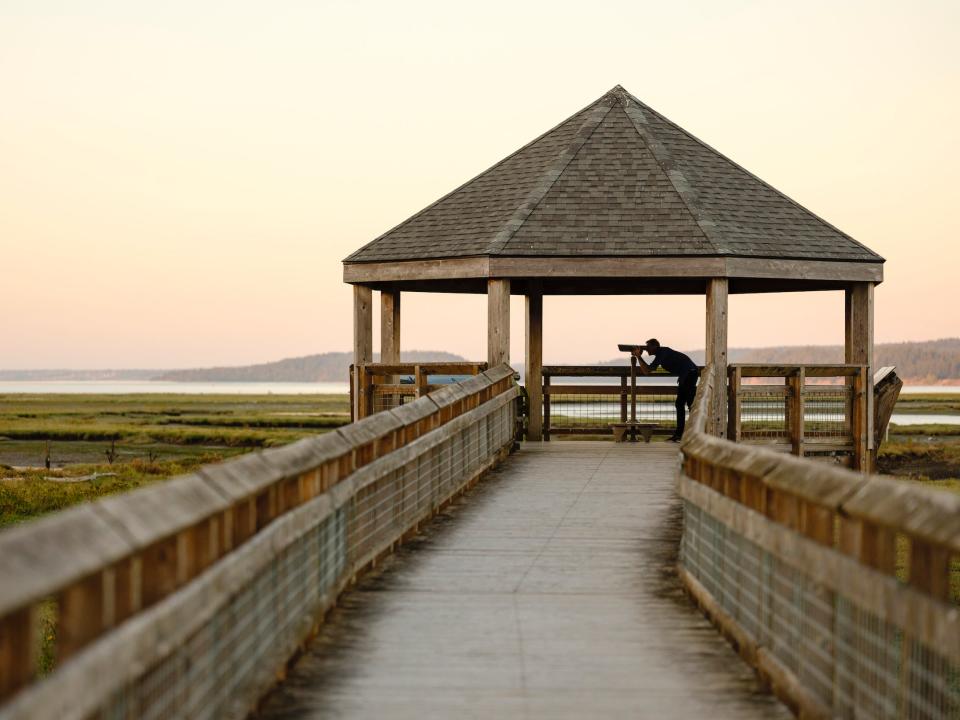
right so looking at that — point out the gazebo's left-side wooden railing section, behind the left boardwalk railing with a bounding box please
[350,362,487,420]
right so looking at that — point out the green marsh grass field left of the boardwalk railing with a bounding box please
[0,394,350,527]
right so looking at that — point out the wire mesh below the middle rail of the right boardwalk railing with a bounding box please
[680,500,960,720]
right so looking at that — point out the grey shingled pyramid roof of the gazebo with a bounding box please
[344,85,883,263]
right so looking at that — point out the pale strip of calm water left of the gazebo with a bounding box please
[0,380,350,395]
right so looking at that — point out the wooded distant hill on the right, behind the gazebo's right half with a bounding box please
[602,338,960,385]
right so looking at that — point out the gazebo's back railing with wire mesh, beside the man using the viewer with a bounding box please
[543,365,677,440]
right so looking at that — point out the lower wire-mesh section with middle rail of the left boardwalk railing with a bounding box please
[9,376,518,720]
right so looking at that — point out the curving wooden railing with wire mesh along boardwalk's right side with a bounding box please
[678,372,960,718]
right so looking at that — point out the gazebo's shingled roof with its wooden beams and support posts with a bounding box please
[344,86,884,450]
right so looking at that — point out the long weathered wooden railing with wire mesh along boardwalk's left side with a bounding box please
[0,365,519,720]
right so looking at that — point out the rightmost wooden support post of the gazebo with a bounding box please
[844,282,875,472]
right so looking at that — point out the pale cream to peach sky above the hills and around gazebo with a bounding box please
[0,0,960,369]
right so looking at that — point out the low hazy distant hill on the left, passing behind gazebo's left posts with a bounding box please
[153,350,465,382]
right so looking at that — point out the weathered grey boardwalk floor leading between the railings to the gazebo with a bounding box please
[260,442,789,720]
